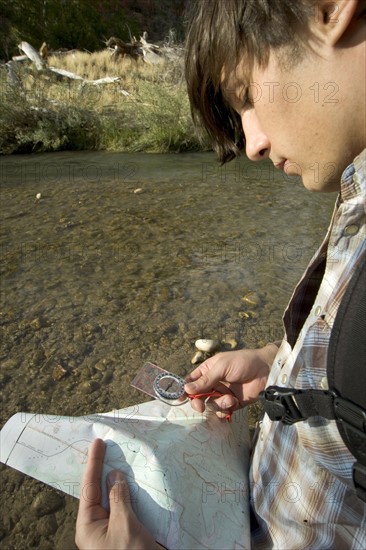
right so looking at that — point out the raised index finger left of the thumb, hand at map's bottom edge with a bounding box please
[79,439,105,521]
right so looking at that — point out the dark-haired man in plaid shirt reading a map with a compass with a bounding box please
[76,0,366,549]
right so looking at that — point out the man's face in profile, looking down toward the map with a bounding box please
[227,44,365,191]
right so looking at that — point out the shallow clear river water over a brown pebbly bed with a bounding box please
[0,152,335,549]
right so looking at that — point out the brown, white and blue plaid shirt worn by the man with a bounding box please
[250,150,366,550]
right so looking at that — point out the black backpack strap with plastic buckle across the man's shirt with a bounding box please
[259,253,366,502]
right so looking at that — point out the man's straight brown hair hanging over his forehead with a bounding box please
[185,0,315,163]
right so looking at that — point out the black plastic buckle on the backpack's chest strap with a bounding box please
[259,386,306,425]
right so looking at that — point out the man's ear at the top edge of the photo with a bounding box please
[315,0,359,46]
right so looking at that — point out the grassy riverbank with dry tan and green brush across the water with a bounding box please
[0,50,209,154]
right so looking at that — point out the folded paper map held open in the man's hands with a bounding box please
[0,400,250,550]
